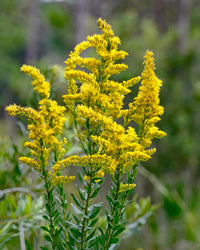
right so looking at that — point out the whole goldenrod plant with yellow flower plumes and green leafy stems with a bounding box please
[6,18,166,250]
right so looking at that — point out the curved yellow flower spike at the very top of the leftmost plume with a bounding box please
[21,65,50,98]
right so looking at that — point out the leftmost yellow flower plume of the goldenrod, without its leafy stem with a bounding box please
[6,65,74,184]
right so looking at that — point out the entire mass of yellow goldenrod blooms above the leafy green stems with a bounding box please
[7,18,166,187]
